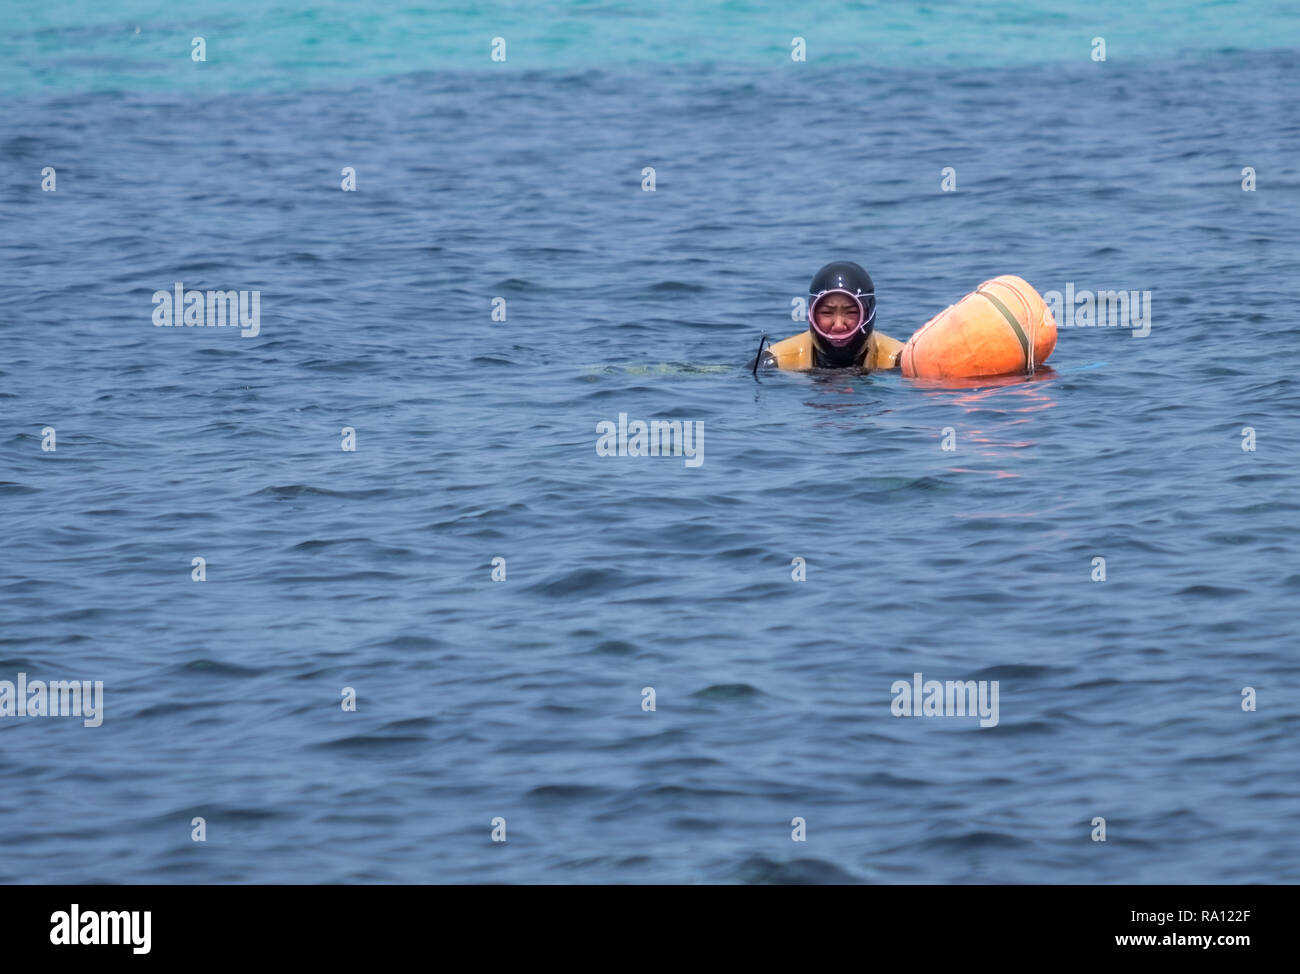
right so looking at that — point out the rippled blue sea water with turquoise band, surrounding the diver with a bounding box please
[0,3,1300,883]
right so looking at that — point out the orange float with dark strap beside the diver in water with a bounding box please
[900,274,1056,378]
